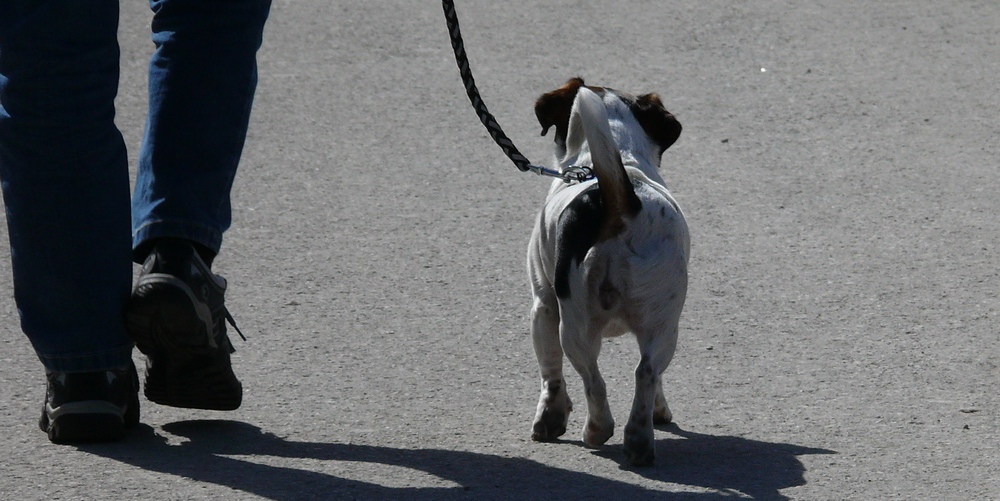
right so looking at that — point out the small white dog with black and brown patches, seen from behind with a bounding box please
[528,78,690,466]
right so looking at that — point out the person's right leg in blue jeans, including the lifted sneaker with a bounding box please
[127,0,270,410]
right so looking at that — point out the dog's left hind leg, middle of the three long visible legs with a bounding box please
[560,313,615,447]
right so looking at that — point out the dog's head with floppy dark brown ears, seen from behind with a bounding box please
[535,77,681,160]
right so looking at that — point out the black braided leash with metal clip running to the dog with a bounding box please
[442,0,594,183]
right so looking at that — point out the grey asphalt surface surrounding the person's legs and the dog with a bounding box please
[0,0,1000,500]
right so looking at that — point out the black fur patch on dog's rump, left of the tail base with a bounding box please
[554,184,604,299]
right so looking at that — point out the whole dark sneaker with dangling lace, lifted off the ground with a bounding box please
[126,240,246,410]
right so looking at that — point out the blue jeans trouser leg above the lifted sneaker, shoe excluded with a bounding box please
[132,0,270,263]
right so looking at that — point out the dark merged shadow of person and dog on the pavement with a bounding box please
[80,421,835,501]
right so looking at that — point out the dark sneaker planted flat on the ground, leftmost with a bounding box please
[38,362,139,443]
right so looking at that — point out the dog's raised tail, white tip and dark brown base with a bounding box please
[567,87,642,240]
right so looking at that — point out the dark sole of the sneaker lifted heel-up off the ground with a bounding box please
[126,274,243,411]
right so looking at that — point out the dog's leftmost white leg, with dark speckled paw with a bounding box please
[531,293,573,442]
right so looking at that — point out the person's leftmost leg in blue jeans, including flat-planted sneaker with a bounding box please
[0,0,138,441]
